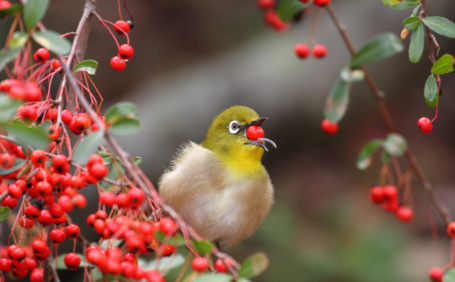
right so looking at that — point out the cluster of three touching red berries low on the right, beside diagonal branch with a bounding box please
[369,185,414,222]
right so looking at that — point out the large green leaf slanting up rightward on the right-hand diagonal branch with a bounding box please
[351,33,404,68]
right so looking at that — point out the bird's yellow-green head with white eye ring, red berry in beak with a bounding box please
[201,106,276,176]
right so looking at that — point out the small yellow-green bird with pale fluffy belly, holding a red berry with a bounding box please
[159,106,276,247]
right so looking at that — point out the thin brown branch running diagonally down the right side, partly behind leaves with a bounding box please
[326,3,451,224]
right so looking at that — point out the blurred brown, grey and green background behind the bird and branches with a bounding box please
[2,0,455,282]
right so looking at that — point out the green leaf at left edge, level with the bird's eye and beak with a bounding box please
[0,120,50,150]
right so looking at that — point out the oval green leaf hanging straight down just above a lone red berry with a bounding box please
[324,78,349,123]
